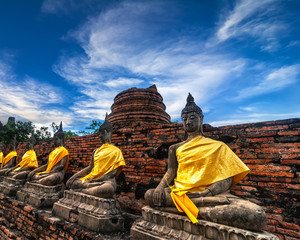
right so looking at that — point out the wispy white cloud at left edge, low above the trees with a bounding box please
[0,61,72,125]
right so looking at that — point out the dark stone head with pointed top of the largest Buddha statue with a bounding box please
[181,93,203,135]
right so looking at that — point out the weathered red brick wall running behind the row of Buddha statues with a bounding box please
[7,118,300,239]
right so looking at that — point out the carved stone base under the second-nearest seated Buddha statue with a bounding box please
[52,190,124,233]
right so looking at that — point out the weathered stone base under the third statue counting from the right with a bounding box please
[16,182,64,208]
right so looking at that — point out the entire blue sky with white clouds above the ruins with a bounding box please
[0,0,300,131]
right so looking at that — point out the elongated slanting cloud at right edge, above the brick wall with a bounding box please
[235,64,300,99]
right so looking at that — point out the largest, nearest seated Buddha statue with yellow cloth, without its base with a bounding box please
[145,94,266,231]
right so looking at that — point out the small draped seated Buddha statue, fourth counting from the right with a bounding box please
[6,134,38,179]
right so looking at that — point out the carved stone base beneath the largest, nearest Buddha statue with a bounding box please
[130,206,279,240]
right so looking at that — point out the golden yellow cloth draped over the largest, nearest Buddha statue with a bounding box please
[171,135,250,223]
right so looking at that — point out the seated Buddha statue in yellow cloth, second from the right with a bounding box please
[66,115,125,198]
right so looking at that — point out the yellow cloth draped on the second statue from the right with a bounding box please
[80,143,125,183]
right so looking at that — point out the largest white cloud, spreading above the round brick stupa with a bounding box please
[54,1,245,118]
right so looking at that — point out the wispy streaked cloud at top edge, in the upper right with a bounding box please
[216,0,288,52]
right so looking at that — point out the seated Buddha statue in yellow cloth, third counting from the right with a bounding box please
[28,122,69,186]
